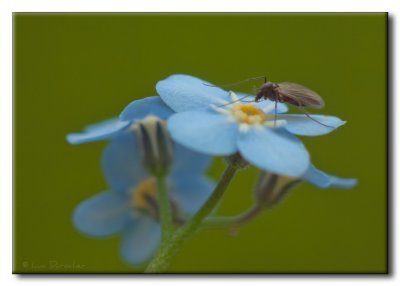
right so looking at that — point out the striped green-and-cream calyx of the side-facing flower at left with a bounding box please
[133,115,174,176]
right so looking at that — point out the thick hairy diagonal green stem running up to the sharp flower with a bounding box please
[145,164,238,273]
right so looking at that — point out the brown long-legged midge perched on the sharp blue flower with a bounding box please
[205,76,334,128]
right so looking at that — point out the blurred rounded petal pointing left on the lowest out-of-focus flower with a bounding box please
[73,192,133,237]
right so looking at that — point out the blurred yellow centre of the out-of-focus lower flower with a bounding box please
[132,178,158,215]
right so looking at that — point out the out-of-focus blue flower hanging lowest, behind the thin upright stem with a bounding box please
[73,130,213,265]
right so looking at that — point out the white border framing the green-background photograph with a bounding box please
[0,0,400,286]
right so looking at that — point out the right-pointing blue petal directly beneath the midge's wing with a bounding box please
[278,114,346,136]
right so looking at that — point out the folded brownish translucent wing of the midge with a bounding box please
[278,82,325,108]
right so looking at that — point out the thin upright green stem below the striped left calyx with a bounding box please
[157,176,174,241]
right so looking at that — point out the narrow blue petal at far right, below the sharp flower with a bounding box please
[302,164,357,189]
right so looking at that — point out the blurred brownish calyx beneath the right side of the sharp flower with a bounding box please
[255,172,302,208]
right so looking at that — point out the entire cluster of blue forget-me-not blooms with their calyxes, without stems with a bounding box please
[67,75,356,264]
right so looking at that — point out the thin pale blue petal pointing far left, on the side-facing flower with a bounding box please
[67,118,129,144]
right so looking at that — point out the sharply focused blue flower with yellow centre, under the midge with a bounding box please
[156,75,345,177]
